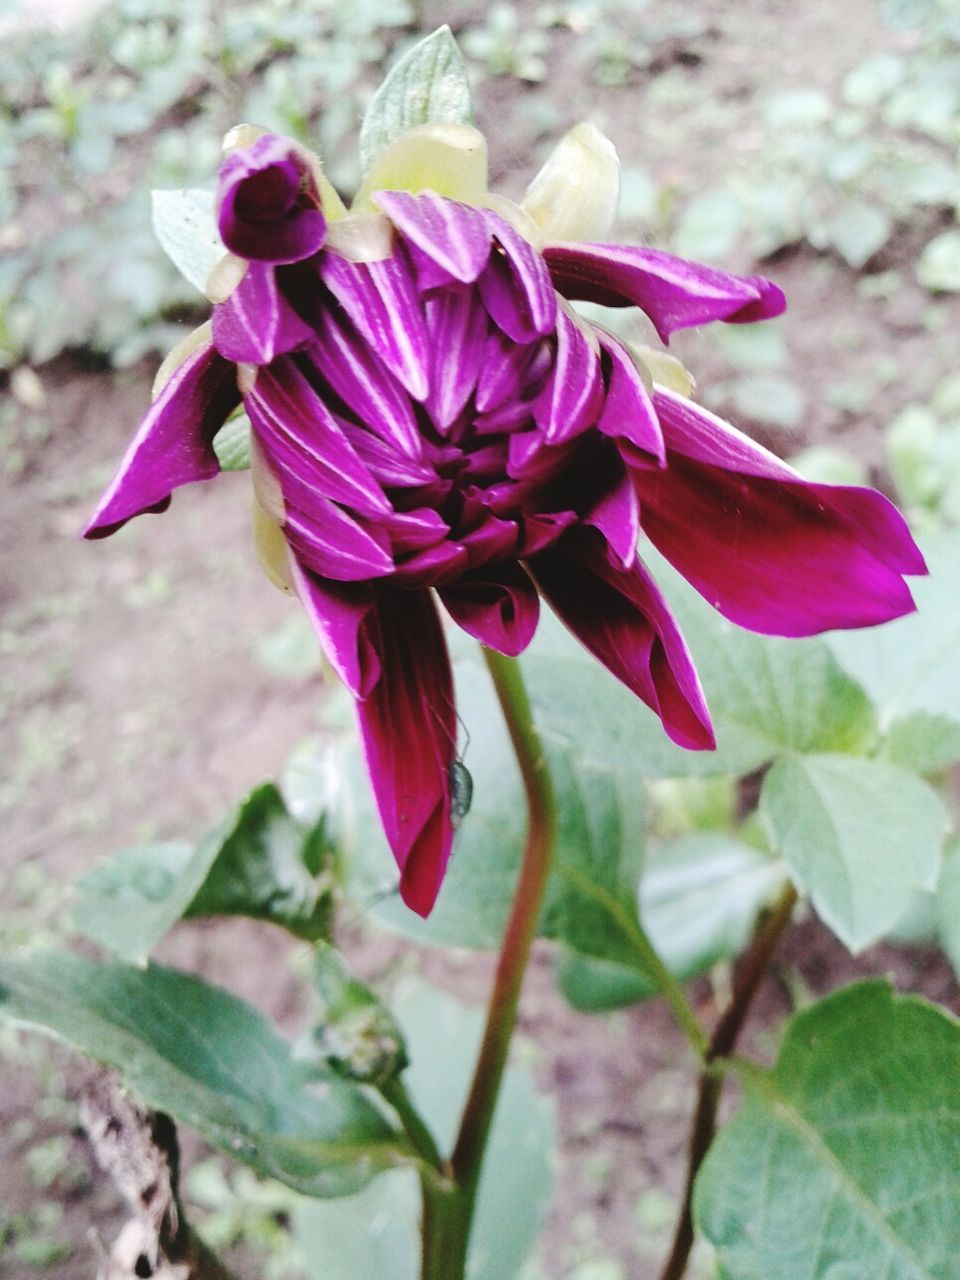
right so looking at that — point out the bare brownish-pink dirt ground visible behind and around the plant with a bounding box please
[0,0,960,1280]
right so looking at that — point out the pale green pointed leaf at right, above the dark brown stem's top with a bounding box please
[760,755,947,951]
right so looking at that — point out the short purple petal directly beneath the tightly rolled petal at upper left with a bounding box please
[214,262,314,365]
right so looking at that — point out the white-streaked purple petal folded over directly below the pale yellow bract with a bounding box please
[374,191,492,288]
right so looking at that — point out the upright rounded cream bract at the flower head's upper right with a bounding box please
[522,124,620,241]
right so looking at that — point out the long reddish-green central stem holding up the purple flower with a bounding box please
[422,649,557,1280]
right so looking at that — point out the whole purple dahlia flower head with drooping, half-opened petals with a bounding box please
[86,136,924,914]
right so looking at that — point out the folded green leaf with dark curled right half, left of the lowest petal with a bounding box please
[73,783,332,964]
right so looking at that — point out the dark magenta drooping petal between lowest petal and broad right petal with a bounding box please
[530,530,716,750]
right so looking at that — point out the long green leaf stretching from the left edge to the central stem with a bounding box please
[0,951,413,1197]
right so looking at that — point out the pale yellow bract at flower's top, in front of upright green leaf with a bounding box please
[352,124,486,212]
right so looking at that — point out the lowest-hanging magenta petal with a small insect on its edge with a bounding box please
[357,591,457,915]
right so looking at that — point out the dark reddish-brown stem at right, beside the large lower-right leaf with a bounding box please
[660,882,797,1280]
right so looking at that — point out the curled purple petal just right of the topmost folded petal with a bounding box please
[480,211,557,343]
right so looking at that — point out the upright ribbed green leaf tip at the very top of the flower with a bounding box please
[360,24,474,172]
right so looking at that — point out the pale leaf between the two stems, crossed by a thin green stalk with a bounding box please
[558,832,783,1011]
